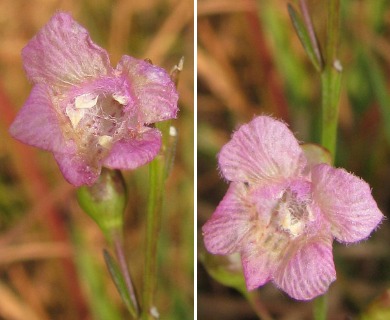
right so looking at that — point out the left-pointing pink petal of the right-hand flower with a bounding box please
[202,183,255,254]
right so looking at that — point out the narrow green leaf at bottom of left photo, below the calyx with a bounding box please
[103,249,137,318]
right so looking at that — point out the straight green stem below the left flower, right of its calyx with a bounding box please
[141,146,165,320]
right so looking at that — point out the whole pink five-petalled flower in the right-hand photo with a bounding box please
[203,116,383,300]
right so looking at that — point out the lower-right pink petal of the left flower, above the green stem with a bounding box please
[103,128,161,169]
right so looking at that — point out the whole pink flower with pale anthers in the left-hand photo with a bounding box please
[10,13,178,186]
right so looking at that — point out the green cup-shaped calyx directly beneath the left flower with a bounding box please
[77,168,127,241]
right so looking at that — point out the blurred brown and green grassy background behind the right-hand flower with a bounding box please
[197,0,390,320]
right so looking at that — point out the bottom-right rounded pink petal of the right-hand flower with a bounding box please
[274,236,336,300]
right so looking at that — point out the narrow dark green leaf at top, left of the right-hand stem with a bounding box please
[288,4,322,72]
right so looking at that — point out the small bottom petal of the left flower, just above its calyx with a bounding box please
[54,153,101,187]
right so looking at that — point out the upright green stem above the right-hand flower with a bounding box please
[321,0,342,159]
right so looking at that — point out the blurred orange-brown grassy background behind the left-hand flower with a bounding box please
[0,0,194,320]
